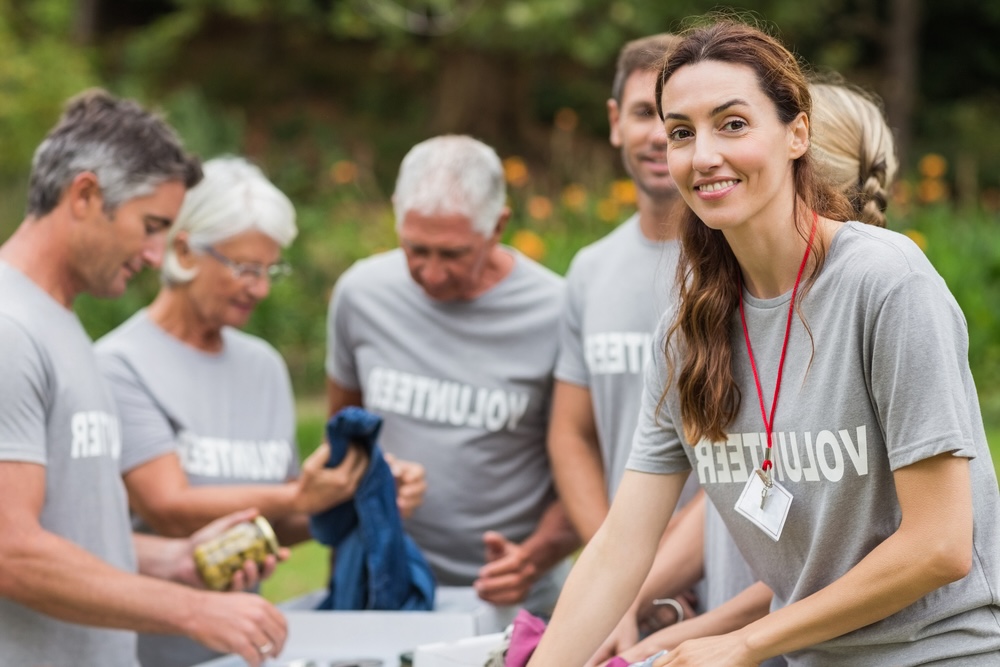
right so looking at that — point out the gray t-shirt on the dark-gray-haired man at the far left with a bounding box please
[0,262,137,667]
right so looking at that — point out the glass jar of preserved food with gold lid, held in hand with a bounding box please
[194,516,281,591]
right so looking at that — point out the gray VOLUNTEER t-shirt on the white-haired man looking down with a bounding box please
[326,248,564,586]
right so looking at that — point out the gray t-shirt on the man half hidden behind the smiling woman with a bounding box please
[555,214,680,498]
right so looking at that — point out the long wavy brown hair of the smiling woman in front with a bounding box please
[656,20,851,443]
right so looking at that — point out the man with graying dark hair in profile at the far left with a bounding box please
[0,91,287,667]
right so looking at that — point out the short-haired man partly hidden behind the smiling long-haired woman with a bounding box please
[548,34,700,656]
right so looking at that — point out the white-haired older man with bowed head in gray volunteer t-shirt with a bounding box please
[326,135,577,615]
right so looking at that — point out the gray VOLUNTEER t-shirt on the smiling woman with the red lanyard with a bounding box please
[628,223,1000,666]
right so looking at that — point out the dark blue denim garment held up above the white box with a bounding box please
[309,407,435,611]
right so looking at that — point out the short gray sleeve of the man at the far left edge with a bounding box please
[0,317,50,465]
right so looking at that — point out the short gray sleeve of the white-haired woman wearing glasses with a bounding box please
[97,352,177,474]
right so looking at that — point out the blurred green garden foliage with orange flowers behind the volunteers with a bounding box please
[0,0,1000,434]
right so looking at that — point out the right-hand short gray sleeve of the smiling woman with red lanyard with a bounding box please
[869,272,978,470]
